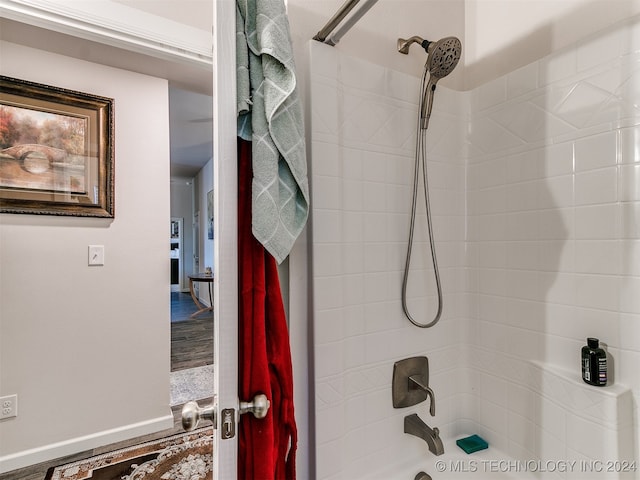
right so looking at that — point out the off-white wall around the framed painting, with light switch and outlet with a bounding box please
[0,42,172,470]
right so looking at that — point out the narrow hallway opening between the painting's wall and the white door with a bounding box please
[169,88,214,405]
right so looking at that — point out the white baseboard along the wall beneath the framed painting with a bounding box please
[0,413,173,474]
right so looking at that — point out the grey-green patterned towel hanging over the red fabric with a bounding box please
[236,0,309,263]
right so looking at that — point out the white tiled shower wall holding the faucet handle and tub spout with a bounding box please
[310,42,468,479]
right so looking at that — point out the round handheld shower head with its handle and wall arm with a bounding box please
[398,36,462,130]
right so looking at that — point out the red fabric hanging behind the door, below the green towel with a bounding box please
[238,139,297,480]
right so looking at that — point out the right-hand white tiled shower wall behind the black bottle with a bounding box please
[467,18,640,472]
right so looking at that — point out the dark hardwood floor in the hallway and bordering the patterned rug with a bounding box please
[0,292,213,480]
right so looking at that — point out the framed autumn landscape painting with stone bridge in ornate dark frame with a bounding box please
[0,76,114,218]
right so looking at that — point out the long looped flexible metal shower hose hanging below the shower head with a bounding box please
[402,64,442,328]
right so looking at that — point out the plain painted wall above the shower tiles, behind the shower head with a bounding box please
[287,0,640,90]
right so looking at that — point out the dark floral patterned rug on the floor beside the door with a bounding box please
[45,427,213,480]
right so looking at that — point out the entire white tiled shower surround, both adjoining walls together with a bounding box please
[310,13,640,479]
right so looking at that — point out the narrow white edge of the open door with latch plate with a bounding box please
[213,0,239,480]
